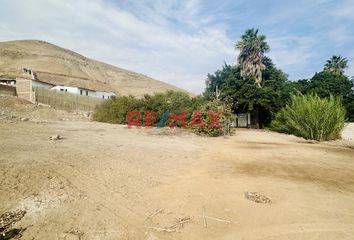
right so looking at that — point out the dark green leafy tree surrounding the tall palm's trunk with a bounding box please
[204,57,289,128]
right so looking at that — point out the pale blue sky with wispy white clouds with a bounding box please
[0,0,354,93]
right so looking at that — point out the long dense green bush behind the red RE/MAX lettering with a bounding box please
[93,91,234,137]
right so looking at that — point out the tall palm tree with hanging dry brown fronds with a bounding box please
[235,28,270,87]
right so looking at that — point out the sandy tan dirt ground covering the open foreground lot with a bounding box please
[0,96,354,240]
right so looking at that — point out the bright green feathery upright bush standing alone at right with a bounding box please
[271,95,345,141]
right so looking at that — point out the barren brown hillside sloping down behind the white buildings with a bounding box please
[0,40,189,96]
